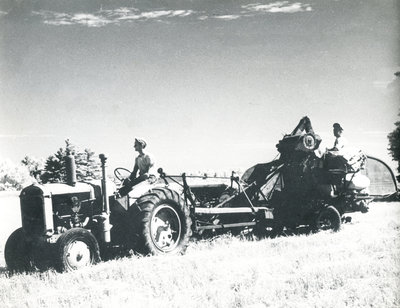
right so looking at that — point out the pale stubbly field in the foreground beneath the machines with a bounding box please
[0,202,400,308]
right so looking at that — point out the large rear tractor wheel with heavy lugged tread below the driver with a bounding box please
[133,188,192,255]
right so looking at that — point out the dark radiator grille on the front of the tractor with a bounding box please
[21,196,46,236]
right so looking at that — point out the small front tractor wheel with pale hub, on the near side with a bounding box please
[56,228,100,272]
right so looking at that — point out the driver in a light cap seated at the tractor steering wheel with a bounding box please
[118,138,154,197]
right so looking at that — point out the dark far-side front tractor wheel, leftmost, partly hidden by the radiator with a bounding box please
[4,228,32,272]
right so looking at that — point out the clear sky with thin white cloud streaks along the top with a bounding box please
[0,0,400,173]
